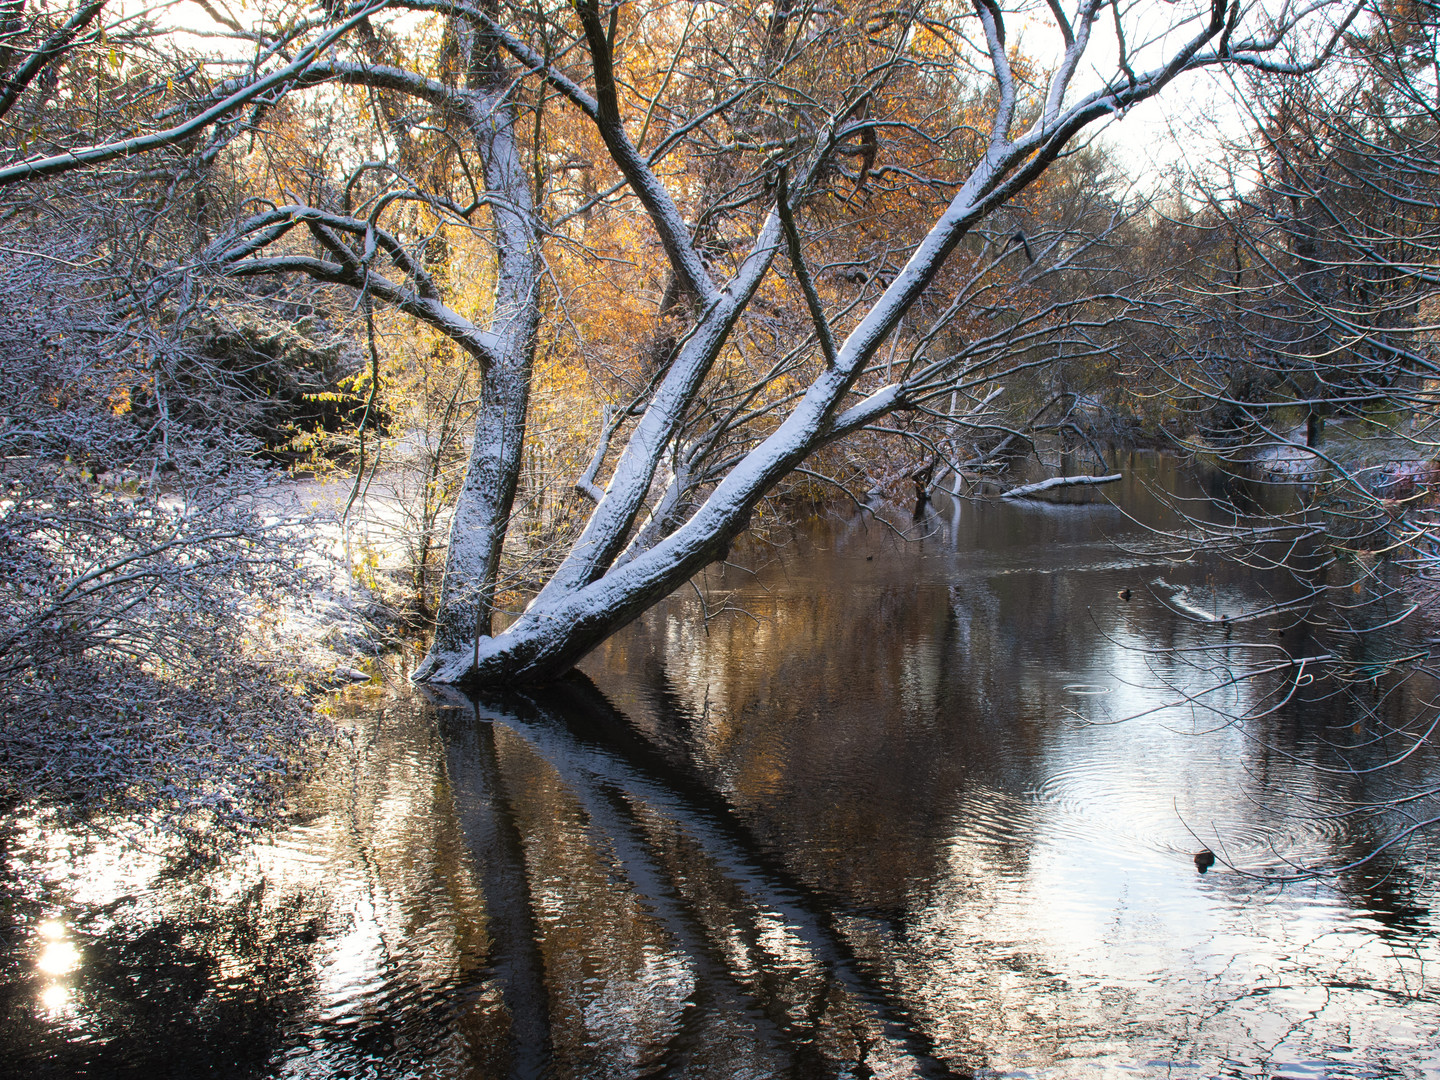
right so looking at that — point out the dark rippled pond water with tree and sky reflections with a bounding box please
[0,459,1440,1077]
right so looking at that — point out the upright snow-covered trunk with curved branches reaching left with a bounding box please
[144,7,541,677]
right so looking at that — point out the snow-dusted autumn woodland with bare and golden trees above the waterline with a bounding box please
[0,0,1440,824]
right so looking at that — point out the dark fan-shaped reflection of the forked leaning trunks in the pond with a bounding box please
[426,678,953,1076]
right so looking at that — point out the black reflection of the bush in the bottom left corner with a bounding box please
[0,868,320,1077]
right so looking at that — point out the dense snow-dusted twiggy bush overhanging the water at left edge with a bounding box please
[0,206,329,831]
